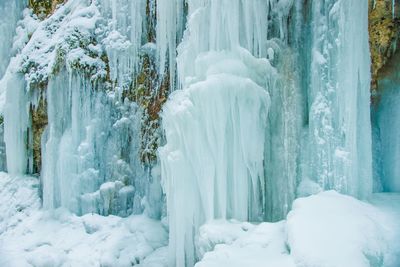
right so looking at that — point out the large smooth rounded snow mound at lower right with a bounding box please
[287,191,386,267]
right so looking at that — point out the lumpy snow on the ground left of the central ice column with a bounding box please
[0,173,168,267]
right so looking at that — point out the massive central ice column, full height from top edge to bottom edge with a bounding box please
[157,0,291,266]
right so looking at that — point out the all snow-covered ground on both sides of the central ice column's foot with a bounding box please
[0,173,400,267]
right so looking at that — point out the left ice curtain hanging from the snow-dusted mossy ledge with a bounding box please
[1,0,162,218]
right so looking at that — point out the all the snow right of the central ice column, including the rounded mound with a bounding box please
[196,191,400,267]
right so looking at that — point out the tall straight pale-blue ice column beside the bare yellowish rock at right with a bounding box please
[305,0,372,200]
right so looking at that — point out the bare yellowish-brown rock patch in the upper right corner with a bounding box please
[369,0,400,99]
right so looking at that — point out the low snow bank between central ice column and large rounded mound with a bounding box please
[195,221,295,267]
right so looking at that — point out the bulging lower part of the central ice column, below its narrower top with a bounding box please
[160,49,270,266]
